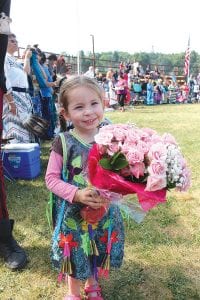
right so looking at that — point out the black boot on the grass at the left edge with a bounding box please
[0,237,27,271]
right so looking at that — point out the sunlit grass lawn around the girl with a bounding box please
[0,104,200,300]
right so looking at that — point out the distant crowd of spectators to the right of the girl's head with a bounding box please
[92,62,200,107]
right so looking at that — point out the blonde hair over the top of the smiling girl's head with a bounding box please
[59,75,104,111]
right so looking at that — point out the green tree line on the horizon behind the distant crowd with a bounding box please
[62,50,200,76]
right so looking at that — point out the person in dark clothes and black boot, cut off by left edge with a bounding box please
[0,0,27,270]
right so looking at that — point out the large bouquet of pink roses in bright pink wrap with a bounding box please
[88,124,190,216]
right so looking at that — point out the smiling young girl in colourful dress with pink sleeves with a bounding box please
[46,76,124,300]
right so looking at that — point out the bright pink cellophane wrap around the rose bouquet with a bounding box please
[88,144,166,211]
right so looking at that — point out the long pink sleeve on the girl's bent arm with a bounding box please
[45,150,78,203]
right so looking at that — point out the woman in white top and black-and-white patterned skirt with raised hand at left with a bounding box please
[3,34,35,143]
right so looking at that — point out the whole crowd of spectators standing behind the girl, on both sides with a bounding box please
[3,34,200,142]
